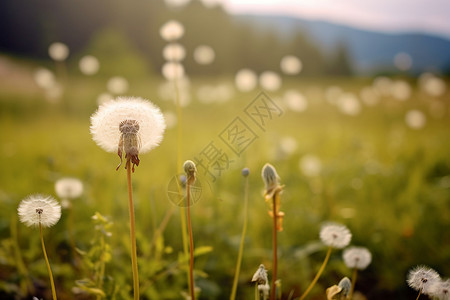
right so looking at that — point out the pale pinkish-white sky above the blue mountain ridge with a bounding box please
[221,0,450,39]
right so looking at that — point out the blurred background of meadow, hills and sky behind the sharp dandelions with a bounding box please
[0,0,450,299]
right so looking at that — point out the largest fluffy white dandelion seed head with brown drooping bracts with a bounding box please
[91,97,166,171]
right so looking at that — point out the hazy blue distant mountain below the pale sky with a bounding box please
[234,15,450,74]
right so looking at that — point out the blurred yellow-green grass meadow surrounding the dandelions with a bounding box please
[0,56,450,299]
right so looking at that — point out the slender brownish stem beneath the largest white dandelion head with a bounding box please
[126,158,139,300]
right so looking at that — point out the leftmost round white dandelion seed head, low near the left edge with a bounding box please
[17,195,61,227]
